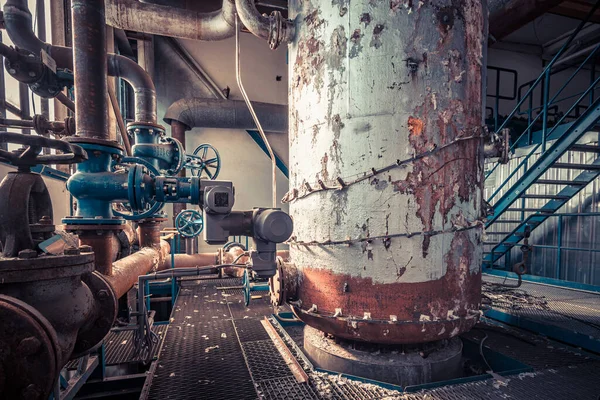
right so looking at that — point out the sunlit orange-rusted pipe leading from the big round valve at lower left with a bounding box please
[106,240,171,298]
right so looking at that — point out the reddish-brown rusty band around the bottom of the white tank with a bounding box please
[295,231,481,343]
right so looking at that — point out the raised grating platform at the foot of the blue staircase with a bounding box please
[483,274,600,340]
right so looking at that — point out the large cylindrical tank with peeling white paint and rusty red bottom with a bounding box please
[285,0,487,344]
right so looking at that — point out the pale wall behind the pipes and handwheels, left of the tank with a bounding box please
[155,34,288,251]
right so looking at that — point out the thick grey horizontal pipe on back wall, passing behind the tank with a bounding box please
[163,97,288,133]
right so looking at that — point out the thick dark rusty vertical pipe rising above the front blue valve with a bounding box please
[71,0,109,140]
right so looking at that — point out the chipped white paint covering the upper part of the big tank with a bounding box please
[289,0,482,283]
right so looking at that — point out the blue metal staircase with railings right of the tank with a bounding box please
[483,1,600,268]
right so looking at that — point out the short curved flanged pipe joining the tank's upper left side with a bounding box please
[235,0,296,49]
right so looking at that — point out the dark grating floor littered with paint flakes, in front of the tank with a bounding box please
[145,279,600,400]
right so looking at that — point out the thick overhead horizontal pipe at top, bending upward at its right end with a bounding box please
[106,0,235,40]
